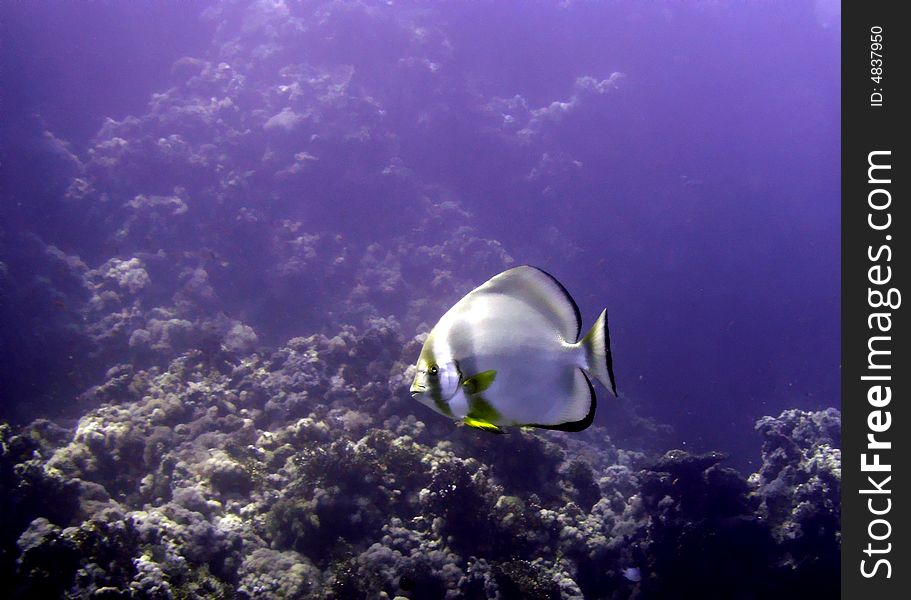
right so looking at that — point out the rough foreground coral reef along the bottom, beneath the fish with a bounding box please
[0,320,839,599]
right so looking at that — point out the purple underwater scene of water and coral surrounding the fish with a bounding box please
[0,0,841,599]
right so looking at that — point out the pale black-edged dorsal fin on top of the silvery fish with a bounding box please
[475,265,582,343]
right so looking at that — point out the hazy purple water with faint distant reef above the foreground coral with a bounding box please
[0,1,839,466]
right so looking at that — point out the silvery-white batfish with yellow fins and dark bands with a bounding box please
[410,265,617,433]
